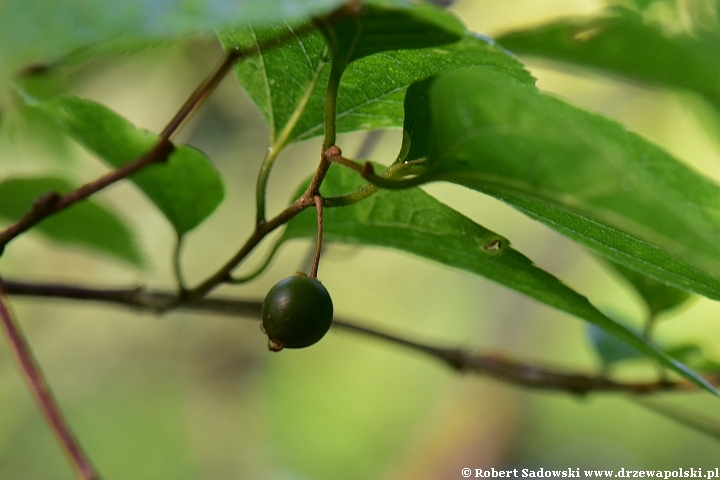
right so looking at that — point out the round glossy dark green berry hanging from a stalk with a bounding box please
[262,275,333,351]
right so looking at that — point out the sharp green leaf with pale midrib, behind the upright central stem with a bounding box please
[220,20,534,148]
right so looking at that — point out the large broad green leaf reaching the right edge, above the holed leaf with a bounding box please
[407,68,720,299]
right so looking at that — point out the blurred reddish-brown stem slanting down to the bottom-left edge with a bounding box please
[0,280,100,480]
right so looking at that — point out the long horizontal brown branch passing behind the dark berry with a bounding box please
[5,281,720,395]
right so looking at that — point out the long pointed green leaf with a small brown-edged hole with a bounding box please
[283,166,715,393]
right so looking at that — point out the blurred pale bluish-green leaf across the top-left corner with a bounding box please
[0,0,352,88]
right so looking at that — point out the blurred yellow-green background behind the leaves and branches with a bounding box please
[0,0,720,480]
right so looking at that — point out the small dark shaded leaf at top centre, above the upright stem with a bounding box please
[319,5,465,70]
